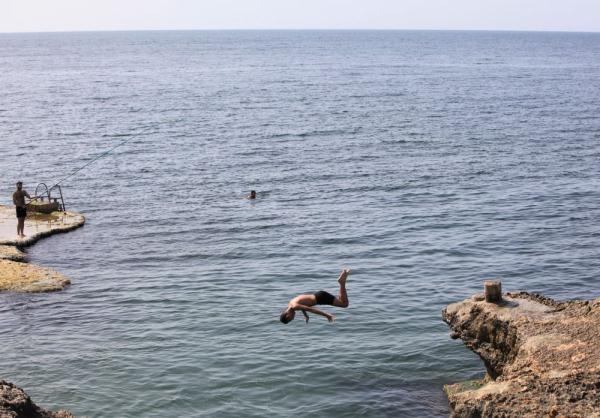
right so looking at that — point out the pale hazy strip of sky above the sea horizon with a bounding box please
[0,0,600,32]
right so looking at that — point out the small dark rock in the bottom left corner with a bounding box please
[0,380,75,418]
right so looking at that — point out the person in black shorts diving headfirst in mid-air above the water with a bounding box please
[279,269,350,324]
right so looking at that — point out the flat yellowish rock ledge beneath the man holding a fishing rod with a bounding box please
[0,205,85,292]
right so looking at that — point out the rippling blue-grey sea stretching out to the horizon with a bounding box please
[0,31,600,417]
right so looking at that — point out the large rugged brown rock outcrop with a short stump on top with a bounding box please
[442,292,600,418]
